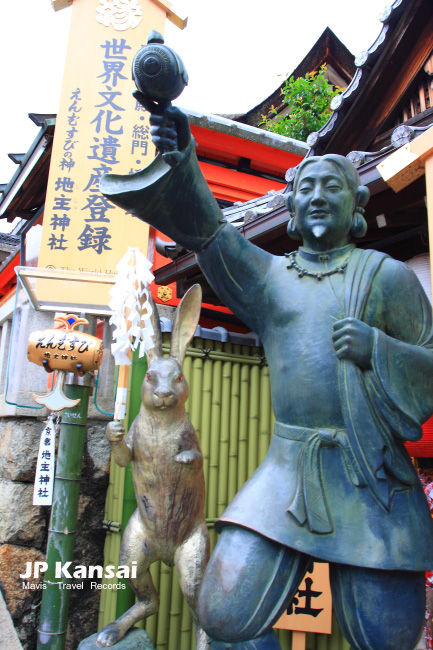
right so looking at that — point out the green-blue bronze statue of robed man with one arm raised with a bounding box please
[101,104,433,650]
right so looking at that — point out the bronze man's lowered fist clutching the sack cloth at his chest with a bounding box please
[332,318,374,370]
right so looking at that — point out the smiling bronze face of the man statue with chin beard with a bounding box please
[294,160,355,251]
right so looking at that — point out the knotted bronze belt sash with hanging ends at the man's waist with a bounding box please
[274,422,365,533]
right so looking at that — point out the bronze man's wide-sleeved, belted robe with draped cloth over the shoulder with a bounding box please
[101,140,433,571]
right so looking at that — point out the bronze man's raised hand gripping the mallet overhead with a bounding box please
[133,90,191,166]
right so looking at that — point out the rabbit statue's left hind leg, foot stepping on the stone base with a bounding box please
[96,511,159,647]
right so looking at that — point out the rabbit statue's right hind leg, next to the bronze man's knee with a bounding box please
[174,521,210,650]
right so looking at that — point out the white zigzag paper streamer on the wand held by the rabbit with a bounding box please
[109,248,154,366]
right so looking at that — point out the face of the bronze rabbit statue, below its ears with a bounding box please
[141,357,188,410]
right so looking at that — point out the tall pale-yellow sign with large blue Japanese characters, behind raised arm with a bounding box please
[38,0,166,280]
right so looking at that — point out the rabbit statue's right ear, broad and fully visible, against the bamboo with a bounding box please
[170,284,201,365]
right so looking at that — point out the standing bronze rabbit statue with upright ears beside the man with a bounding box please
[97,285,209,650]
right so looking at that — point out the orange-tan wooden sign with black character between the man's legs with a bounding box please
[274,562,332,634]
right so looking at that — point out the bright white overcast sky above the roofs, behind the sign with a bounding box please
[0,0,386,183]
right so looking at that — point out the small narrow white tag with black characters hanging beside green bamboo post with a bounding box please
[33,414,56,506]
